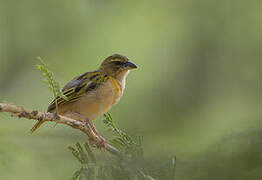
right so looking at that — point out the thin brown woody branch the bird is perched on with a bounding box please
[0,103,120,155]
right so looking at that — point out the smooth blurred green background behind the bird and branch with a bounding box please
[0,0,262,180]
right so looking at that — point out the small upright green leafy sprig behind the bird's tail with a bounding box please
[36,57,67,114]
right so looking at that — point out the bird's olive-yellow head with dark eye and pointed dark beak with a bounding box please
[99,54,137,77]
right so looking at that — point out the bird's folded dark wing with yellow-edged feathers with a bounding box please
[47,71,108,112]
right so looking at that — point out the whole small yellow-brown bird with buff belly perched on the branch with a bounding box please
[31,54,137,145]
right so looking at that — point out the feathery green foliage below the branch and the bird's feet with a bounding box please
[69,113,176,180]
